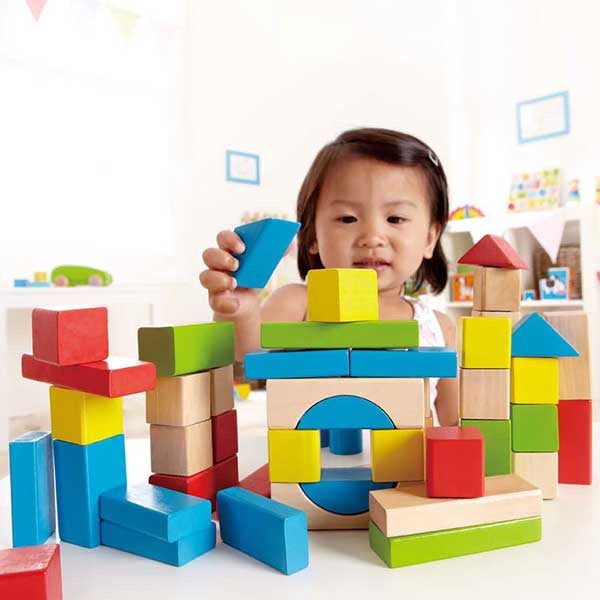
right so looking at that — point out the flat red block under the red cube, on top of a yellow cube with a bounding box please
[21,354,156,398]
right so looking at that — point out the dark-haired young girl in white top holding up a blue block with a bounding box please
[200,129,458,425]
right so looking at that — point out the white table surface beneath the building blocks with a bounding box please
[0,392,600,600]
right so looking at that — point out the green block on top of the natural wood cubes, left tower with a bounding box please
[138,321,234,377]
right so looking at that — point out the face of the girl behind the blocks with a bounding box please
[309,158,441,295]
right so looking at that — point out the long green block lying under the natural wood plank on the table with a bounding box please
[369,517,542,568]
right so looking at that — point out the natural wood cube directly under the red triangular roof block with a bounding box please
[473,267,521,312]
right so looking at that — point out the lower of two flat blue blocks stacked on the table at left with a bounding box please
[100,521,216,567]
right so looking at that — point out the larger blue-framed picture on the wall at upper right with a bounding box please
[517,92,570,144]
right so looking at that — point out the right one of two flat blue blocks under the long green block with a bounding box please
[350,347,457,377]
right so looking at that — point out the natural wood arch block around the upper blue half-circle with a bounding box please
[267,377,429,429]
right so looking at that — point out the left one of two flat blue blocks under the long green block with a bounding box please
[244,349,350,379]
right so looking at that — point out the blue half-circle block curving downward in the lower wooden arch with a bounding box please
[300,467,396,515]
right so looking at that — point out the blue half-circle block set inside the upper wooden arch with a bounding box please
[296,395,395,429]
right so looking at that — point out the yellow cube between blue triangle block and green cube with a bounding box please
[510,357,558,404]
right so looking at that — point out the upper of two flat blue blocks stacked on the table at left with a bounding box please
[100,483,211,542]
